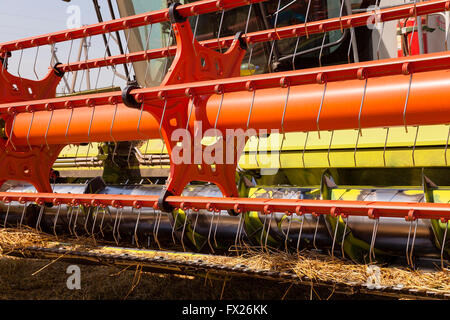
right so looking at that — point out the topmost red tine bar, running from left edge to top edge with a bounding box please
[0,0,266,54]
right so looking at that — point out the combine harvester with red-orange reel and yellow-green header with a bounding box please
[0,0,450,298]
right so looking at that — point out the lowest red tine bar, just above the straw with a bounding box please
[0,192,450,222]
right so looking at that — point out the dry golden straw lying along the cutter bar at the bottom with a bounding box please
[0,229,450,293]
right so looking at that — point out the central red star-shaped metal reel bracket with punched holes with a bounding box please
[138,10,246,197]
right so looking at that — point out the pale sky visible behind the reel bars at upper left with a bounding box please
[0,0,130,91]
